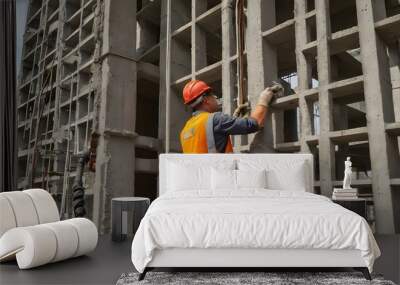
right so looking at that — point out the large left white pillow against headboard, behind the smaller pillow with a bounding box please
[167,161,235,191]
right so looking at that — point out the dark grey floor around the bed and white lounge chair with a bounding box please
[0,235,400,285]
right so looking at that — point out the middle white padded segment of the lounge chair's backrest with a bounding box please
[1,191,39,227]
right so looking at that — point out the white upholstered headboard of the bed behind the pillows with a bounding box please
[158,153,314,196]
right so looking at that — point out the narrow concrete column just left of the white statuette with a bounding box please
[315,0,335,196]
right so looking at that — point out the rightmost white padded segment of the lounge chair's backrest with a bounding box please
[22,189,60,224]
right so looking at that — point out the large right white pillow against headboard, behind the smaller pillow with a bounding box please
[238,160,308,191]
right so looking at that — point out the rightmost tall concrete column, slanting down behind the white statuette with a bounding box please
[356,0,400,234]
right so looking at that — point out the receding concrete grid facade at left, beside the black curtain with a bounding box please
[18,0,97,217]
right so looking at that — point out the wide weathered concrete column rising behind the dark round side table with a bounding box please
[93,0,137,233]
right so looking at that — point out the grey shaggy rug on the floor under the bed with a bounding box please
[117,271,395,285]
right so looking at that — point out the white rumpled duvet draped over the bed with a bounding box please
[132,189,380,272]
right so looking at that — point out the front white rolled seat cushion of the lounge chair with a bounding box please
[0,218,98,269]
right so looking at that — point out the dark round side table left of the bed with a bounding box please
[111,197,150,241]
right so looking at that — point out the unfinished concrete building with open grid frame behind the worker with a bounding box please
[18,0,400,233]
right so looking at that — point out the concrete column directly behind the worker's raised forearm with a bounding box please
[246,0,278,152]
